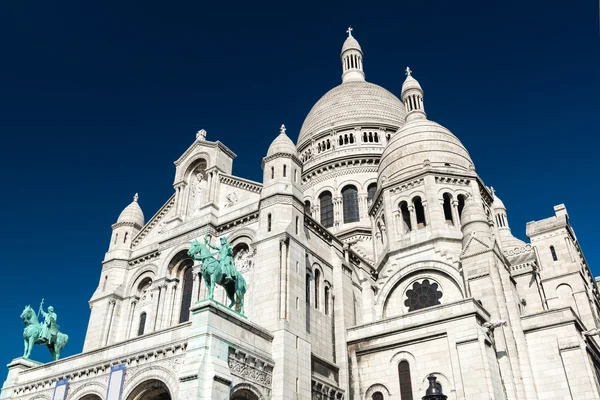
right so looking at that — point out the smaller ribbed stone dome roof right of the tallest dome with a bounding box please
[378,119,474,187]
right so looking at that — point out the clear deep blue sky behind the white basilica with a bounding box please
[0,0,600,362]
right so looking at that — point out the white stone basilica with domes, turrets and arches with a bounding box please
[0,29,600,400]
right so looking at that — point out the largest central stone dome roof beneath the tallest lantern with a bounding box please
[298,81,406,145]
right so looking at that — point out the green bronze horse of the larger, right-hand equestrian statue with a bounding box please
[188,240,246,315]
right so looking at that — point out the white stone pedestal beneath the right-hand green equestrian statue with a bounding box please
[178,299,273,400]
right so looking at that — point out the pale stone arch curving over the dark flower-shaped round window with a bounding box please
[376,260,465,318]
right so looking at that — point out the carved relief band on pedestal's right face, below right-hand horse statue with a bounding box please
[228,347,275,389]
